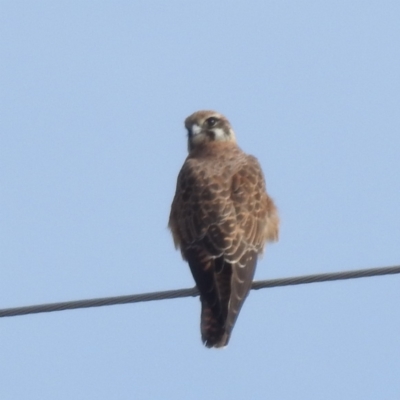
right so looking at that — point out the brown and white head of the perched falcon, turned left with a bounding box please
[185,111,236,152]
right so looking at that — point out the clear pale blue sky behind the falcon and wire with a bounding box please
[0,0,400,400]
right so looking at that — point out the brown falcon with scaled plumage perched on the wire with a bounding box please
[168,110,279,348]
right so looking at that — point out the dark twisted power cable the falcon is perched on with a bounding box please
[0,266,400,318]
